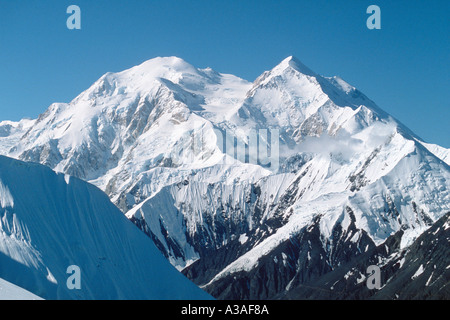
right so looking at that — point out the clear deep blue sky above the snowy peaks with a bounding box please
[0,0,450,148]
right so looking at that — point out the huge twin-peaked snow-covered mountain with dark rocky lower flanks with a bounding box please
[0,57,450,298]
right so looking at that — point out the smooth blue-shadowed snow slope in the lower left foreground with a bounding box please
[0,156,209,299]
